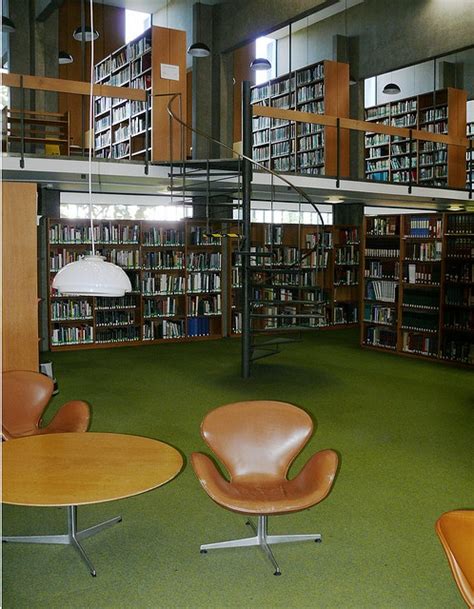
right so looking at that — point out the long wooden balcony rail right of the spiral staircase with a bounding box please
[252,105,469,148]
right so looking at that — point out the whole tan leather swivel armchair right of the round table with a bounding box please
[191,400,338,575]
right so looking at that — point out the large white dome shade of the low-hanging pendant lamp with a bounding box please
[53,255,132,296]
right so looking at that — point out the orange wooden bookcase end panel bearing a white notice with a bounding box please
[151,26,187,161]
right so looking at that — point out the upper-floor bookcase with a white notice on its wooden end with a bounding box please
[94,26,186,161]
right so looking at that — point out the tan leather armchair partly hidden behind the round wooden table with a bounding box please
[2,370,90,440]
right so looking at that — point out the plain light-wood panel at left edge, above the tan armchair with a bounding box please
[1,182,39,371]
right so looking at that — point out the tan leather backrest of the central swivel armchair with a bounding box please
[201,400,313,481]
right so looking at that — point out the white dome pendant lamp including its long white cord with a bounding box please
[53,0,132,297]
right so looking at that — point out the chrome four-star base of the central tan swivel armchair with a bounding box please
[200,516,322,575]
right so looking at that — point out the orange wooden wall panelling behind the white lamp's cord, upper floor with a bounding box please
[59,0,125,146]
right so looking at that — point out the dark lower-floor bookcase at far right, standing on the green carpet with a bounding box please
[361,213,474,364]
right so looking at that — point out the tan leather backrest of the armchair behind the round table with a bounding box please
[2,370,54,439]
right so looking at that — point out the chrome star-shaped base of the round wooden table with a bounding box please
[2,505,122,577]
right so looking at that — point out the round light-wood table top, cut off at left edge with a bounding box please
[2,432,183,506]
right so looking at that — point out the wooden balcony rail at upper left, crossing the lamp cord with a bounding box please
[2,74,146,101]
